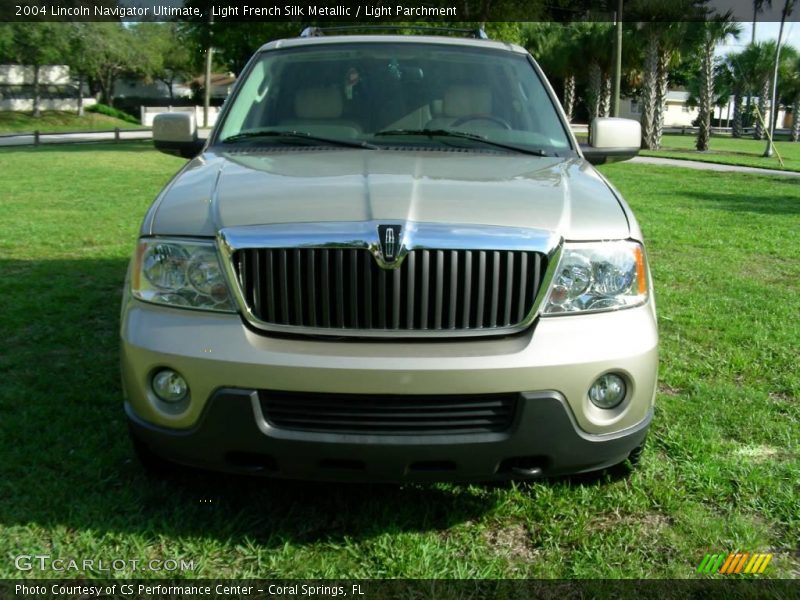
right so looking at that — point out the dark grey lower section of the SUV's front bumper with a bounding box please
[125,389,652,482]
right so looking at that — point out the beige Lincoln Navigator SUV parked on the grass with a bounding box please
[121,31,658,482]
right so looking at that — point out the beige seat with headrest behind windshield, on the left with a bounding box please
[280,85,361,137]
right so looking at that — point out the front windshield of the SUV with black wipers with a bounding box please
[217,42,570,155]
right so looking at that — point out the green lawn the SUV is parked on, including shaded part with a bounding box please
[0,144,800,578]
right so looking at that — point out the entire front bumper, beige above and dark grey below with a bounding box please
[121,298,658,481]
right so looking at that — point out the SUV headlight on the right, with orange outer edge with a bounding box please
[544,241,647,315]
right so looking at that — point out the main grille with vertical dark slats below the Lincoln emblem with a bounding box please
[232,248,545,332]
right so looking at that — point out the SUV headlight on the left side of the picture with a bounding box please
[132,239,234,312]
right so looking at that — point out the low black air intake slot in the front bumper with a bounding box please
[259,390,517,435]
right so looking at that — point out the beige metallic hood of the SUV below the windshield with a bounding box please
[143,147,630,240]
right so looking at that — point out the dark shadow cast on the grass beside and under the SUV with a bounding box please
[0,259,636,548]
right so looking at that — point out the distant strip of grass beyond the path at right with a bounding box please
[641,134,800,171]
